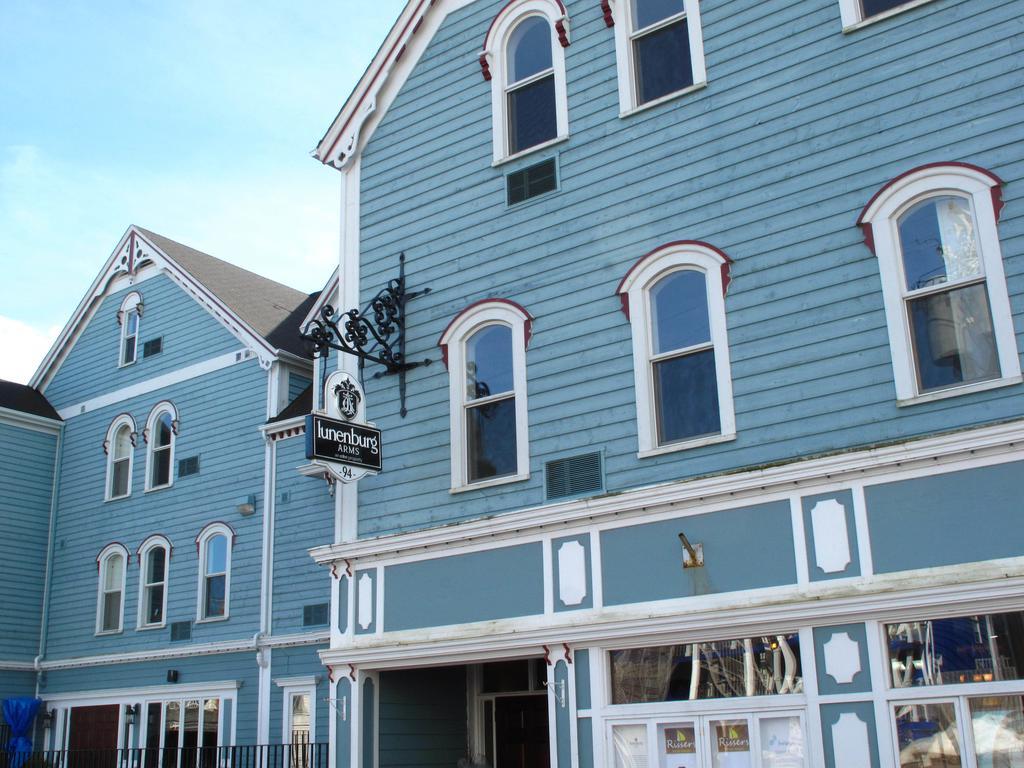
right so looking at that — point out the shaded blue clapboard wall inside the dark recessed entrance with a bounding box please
[379,667,468,768]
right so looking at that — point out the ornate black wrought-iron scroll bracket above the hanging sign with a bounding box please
[302,253,431,418]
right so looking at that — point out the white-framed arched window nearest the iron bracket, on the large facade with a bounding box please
[440,299,531,490]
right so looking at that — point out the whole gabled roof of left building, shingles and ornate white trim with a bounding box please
[30,225,318,390]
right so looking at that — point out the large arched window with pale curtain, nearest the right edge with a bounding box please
[859,164,1021,401]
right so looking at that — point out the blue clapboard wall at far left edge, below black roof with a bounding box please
[0,423,57,663]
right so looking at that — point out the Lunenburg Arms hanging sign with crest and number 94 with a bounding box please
[306,371,382,482]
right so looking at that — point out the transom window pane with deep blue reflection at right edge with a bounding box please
[886,611,1024,688]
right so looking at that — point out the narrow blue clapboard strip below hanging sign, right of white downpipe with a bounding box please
[272,435,334,634]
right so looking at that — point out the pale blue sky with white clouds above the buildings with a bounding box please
[0,0,404,383]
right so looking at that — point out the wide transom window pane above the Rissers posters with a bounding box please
[611,634,803,705]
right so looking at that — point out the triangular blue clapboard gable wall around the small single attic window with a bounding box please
[43,274,243,409]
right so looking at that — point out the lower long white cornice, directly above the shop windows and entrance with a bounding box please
[321,569,1024,669]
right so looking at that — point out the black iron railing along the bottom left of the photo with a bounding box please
[0,742,328,768]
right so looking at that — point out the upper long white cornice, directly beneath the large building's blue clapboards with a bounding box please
[309,421,1024,564]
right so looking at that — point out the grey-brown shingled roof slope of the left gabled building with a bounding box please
[137,227,317,357]
